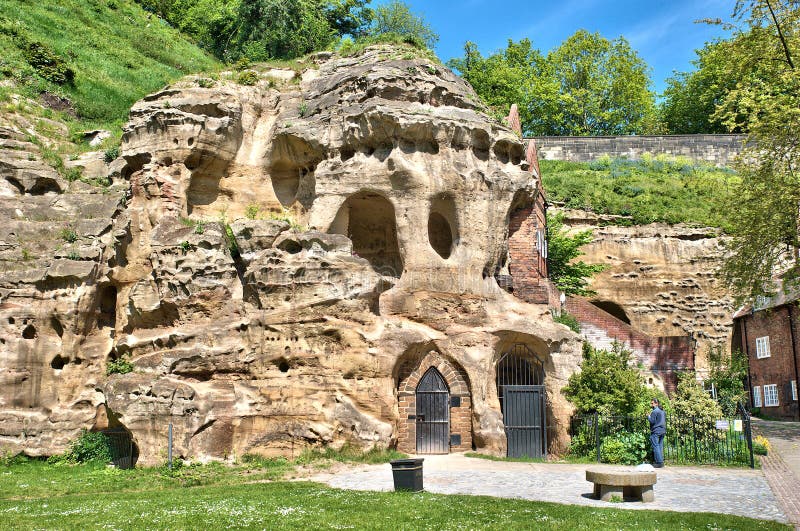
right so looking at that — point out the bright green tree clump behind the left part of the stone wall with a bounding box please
[448,30,656,135]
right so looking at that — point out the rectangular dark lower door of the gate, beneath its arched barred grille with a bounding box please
[503,385,547,457]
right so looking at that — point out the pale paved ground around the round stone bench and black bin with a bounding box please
[310,454,788,522]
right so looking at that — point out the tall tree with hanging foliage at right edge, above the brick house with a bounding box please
[714,0,800,301]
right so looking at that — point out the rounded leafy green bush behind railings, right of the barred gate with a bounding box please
[563,343,646,415]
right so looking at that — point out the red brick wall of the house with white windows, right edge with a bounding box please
[737,306,800,420]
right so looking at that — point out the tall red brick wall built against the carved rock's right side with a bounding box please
[508,194,551,304]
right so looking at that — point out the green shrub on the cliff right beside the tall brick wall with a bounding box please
[547,214,606,295]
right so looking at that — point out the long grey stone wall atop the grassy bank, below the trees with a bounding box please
[534,135,745,166]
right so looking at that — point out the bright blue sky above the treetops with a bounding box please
[382,0,734,92]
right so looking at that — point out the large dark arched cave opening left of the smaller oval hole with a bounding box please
[328,192,403,278]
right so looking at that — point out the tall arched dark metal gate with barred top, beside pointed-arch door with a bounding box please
[497,344,547,457]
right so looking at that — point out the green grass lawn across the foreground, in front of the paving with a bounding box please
[0,460,787,529]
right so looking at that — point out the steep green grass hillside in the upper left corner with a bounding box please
[0,0,218,129]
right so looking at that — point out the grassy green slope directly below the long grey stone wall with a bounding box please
[539,156,737,228]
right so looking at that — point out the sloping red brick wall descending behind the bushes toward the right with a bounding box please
[566,297,694,392]
